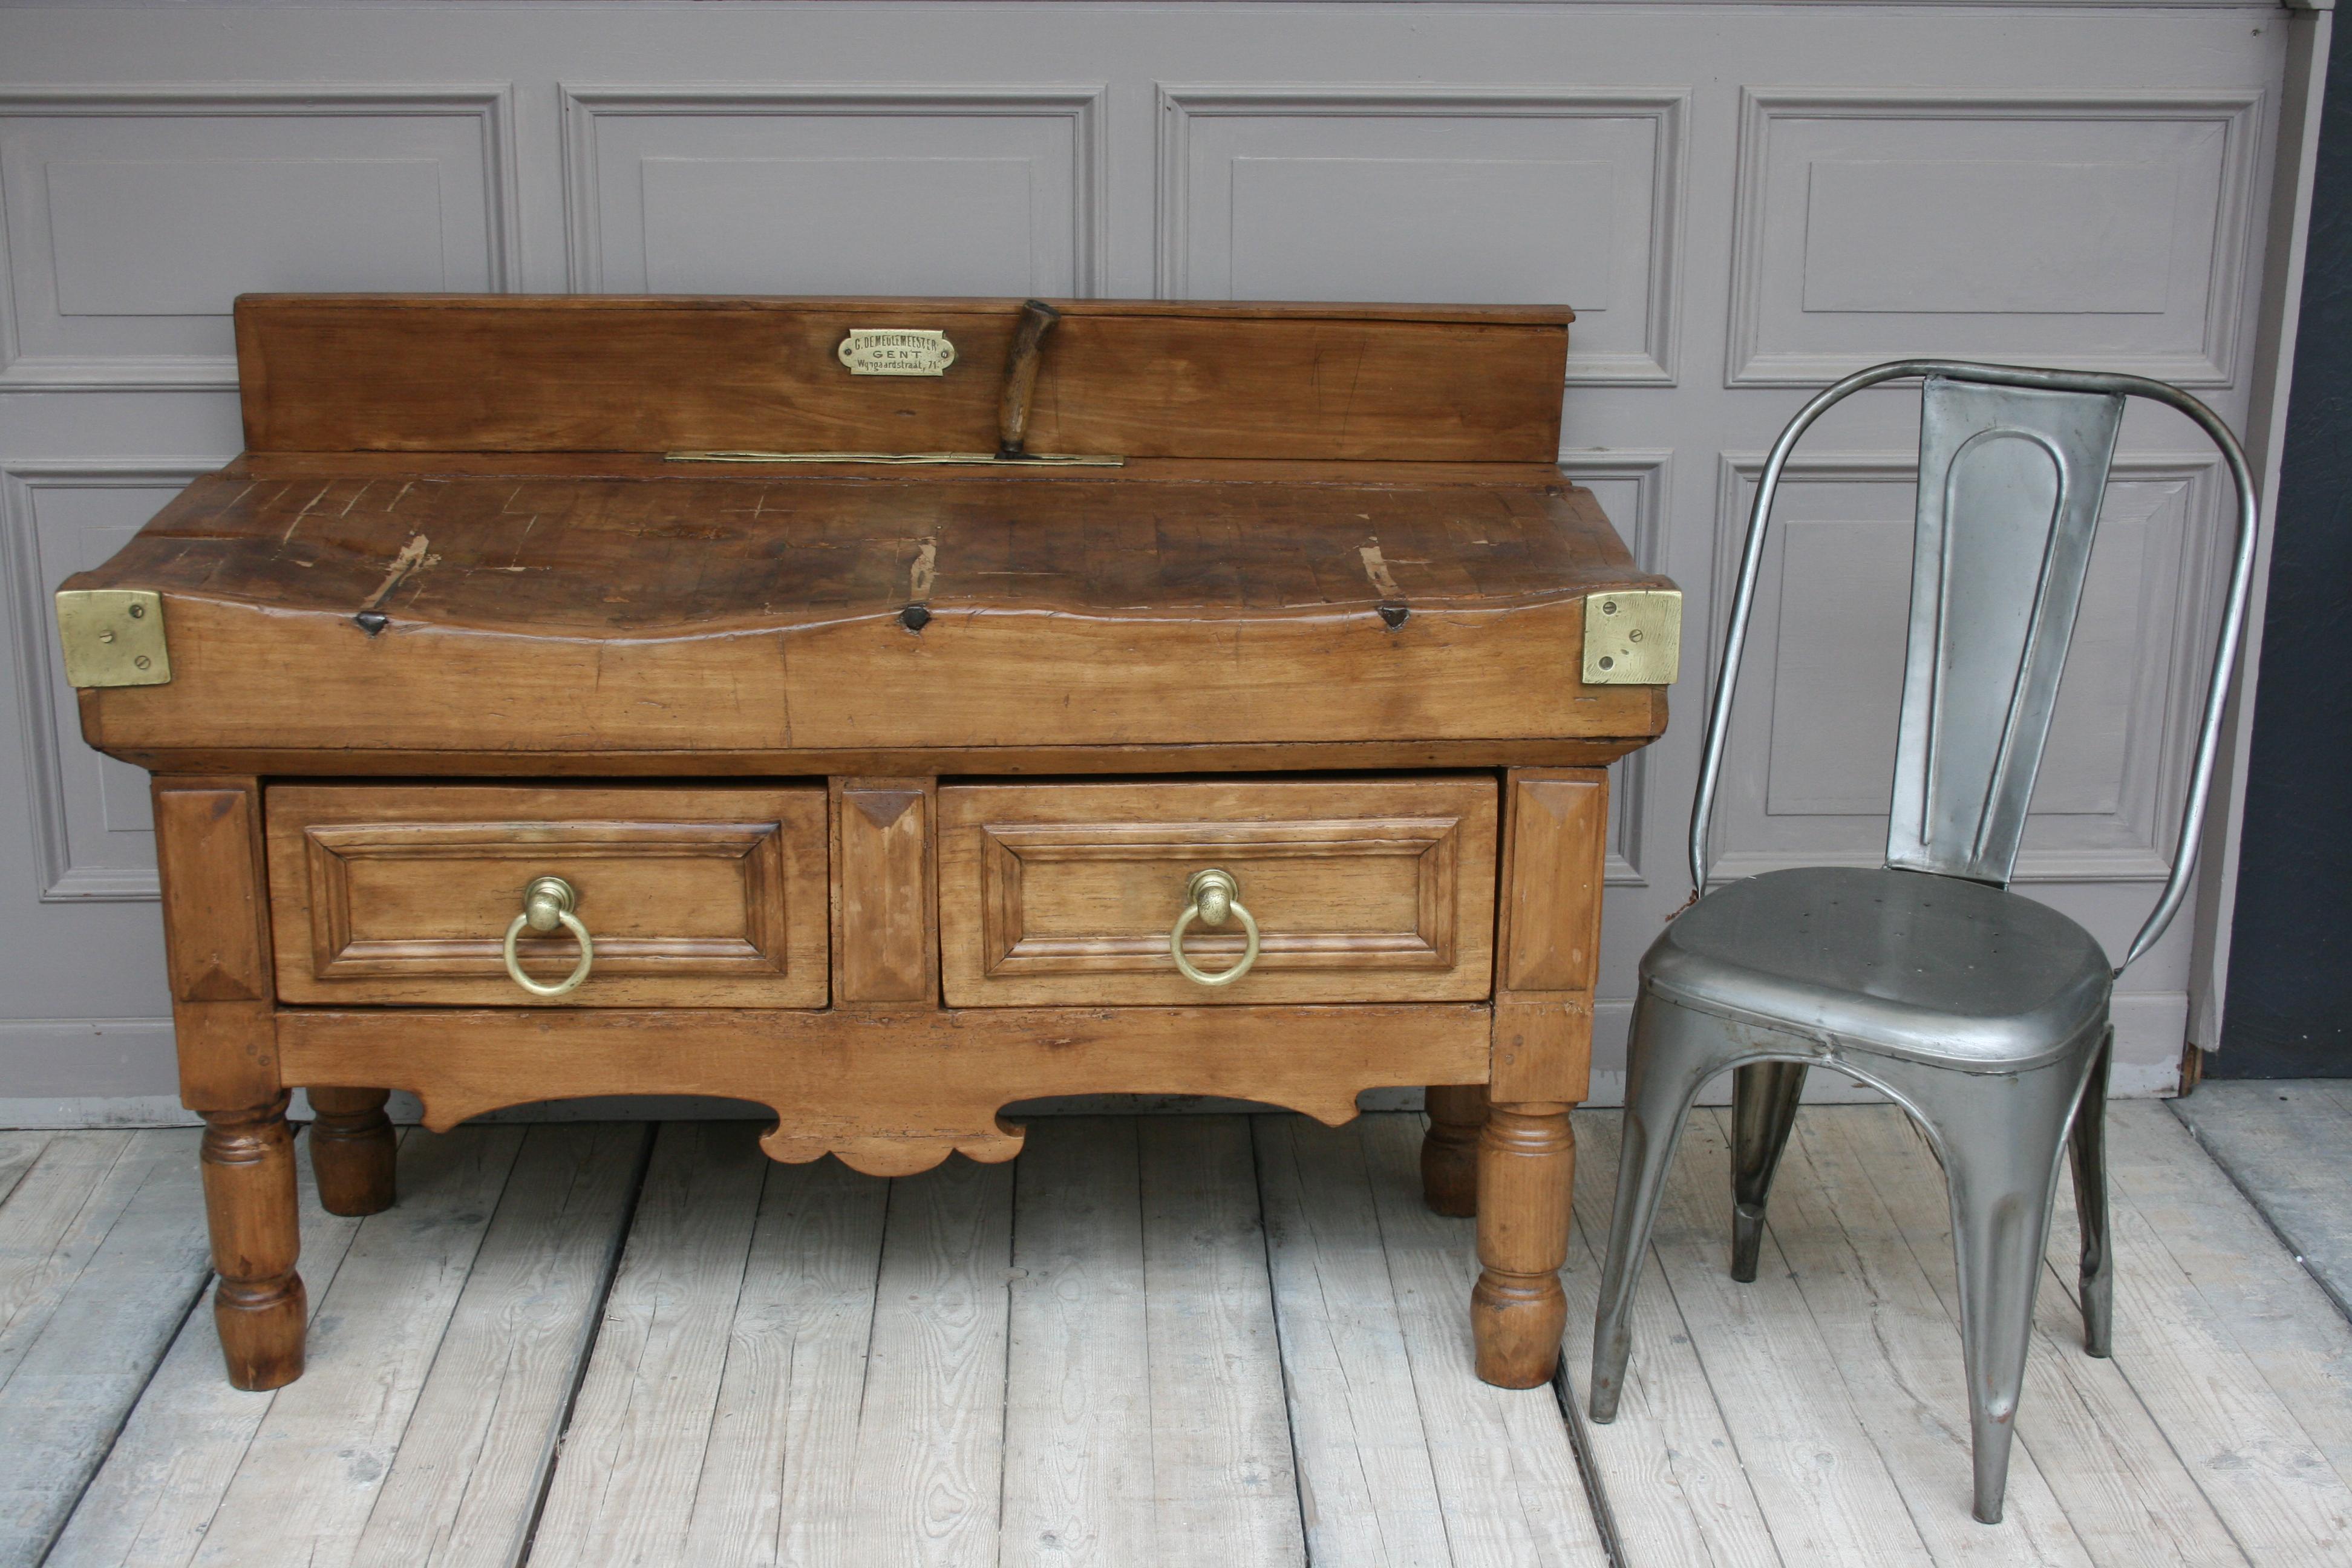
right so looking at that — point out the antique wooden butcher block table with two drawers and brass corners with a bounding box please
[59,296,1679,1390]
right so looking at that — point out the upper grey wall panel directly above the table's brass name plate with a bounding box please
[564,87,1103,296]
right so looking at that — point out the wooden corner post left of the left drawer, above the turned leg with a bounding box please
[153,776,280,1112]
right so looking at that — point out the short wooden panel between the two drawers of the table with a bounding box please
[832,778,938,1001]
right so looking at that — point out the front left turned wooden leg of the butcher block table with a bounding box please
[202,1093,310,1390]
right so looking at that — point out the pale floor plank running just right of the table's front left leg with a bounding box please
[195,1126,522,1568]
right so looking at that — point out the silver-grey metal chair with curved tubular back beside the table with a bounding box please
[1592,360,2256,1523]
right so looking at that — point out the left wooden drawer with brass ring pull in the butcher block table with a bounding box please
[268,785,828,1006]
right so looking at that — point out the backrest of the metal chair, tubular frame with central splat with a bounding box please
[1691,360,2256,973]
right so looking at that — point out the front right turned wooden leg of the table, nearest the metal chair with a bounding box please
[1470,1105,1576,1390]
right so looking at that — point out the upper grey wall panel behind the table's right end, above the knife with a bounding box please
[1160,87,1687,385]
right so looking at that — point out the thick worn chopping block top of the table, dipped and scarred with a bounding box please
[71,470,1665,753]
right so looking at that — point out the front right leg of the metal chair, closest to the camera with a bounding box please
[1880,1058,2091,1523]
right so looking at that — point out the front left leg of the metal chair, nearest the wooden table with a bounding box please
[1592,992,1738,1425]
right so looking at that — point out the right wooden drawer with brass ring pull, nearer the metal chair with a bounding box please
[938,776,1498,1006]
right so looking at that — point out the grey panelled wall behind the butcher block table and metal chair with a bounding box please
[0,0,2326,1114]
